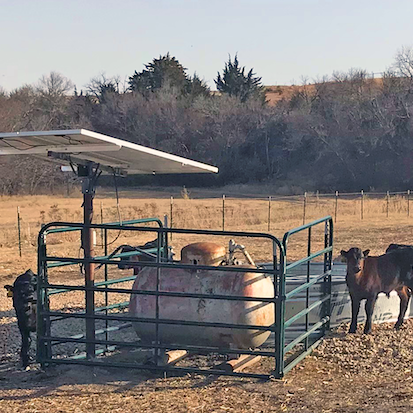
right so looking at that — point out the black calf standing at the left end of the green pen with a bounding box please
[4,270,37,367]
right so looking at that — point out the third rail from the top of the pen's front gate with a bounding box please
[43,284,276,304]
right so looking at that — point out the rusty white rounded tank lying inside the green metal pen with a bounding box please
[129,242,274,349]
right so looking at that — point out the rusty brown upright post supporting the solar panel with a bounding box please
[82,166,95,359]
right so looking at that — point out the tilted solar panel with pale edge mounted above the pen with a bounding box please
[0,129,218,174]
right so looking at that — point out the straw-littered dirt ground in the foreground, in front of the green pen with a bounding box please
[0,321,413,413]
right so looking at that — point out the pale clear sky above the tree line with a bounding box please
[0,0,413,91]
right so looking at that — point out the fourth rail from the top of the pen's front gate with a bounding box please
[41,311,275,331]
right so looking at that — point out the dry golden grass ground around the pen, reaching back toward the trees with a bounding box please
[0,188,413,413]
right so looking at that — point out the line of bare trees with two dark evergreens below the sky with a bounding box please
[0,48,413,194]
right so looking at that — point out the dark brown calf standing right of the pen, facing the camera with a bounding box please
[341,247,413,334]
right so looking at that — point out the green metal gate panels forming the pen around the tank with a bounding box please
[37,217,333,379]
